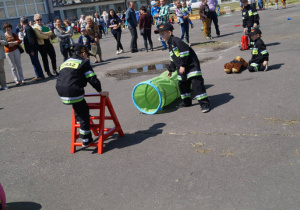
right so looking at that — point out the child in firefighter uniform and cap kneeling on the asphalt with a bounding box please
[248,28,269,72]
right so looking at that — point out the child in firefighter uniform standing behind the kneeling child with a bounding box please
[241,0,259,48]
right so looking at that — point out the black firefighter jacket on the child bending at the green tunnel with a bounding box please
[168,35,202,80]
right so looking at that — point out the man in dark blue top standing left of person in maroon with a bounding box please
[125,1,138,53]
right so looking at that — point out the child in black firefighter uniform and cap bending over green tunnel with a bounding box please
[154,23,210,113]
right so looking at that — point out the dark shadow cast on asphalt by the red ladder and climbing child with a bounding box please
[102,123,166,153]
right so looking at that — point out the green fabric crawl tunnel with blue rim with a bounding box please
[132,71,180,114]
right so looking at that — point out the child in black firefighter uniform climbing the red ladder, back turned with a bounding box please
[56,43,108,147]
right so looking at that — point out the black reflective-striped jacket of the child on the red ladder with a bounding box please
[56,55,102,104]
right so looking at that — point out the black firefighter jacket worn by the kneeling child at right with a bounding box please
[249,38,269,63]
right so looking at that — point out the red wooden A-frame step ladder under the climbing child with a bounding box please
[71,93,124,154]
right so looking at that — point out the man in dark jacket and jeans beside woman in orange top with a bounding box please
[20,17,45,81]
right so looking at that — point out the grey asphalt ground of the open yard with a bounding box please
[0,4,300,210]
